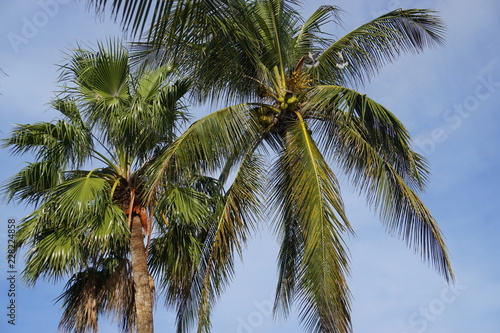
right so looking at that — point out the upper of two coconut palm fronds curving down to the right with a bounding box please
[304,86,429,191]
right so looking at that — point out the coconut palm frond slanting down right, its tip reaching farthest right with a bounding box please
[335,120,453,281]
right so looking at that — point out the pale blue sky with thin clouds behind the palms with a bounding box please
[0,0,500,333]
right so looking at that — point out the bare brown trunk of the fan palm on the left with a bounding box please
[130,215,153,333]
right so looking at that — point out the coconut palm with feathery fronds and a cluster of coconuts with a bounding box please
[129,0,453,332]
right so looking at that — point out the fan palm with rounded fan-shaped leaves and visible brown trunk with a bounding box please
[3,41,215,333]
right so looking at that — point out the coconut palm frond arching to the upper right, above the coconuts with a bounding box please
[314,9,445,84]
